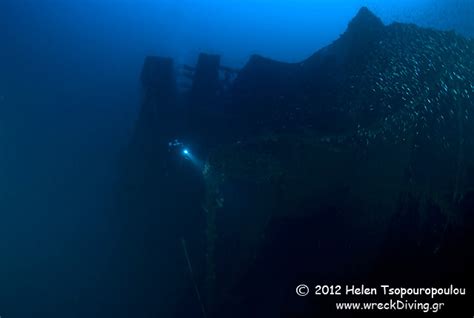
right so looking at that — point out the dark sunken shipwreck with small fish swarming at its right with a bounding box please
[116,8,474,317]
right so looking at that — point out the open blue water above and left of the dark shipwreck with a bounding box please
[0,0,474,318]
